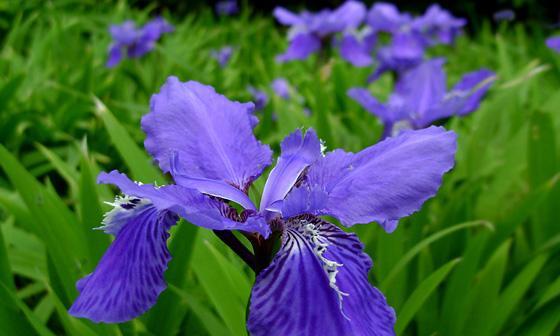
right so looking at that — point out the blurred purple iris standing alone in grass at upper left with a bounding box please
[107,17,174,68]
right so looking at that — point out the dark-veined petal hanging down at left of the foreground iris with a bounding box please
[69,205,177,323]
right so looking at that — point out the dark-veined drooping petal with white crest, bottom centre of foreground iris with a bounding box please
[247,216,395,336]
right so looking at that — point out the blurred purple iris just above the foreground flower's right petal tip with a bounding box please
[348,58,495,138]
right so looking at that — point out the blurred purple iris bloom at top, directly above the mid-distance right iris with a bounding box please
[340,2,466,81]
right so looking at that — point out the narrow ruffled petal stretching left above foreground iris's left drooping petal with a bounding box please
[98,171,270,237]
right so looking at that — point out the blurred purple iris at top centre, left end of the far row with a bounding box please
[274,0,366,62]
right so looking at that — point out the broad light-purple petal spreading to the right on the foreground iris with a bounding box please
[306,127,457,231]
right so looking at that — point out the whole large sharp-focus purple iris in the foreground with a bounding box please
[70,77,456,336]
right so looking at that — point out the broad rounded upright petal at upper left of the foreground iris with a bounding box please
[142,77,272,190]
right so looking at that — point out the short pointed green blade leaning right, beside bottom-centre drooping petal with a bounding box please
[395,259,461,335]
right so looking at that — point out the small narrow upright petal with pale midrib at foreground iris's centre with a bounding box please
[260,129,321,211]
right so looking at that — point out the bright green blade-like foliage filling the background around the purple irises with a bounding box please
[0,0,560,335]
